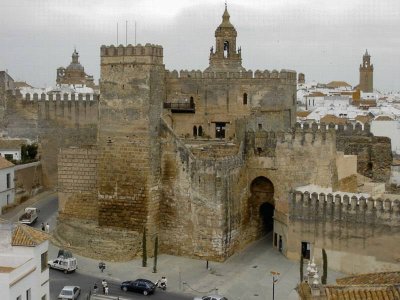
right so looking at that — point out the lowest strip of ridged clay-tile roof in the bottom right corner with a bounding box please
[325,285,400,300]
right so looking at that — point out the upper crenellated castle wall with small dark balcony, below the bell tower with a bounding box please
[164,70,296,139]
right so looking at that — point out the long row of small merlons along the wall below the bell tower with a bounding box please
[166,70,296,80]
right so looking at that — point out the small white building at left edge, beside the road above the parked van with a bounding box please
[0,156,15,215]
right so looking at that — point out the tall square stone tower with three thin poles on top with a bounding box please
[97,44,165,238]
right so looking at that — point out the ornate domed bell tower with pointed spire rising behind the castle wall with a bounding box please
[206,3,244,72]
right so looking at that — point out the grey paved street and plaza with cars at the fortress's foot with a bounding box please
[1,193,342,300]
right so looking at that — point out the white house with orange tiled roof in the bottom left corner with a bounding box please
[0,222,50,300]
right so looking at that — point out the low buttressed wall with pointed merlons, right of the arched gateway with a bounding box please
[288,191,400,272]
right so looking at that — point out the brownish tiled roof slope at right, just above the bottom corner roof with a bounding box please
[336,271,400,285]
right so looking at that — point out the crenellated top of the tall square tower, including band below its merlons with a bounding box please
[100,43,163,65]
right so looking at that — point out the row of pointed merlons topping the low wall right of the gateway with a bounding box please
[290,190,400,224]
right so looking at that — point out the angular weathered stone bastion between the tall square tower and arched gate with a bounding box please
[160,119,245,261]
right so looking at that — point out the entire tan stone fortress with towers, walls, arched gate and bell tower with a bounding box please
[0,7,400,272]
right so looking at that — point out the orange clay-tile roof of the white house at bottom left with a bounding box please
[11,224,49,247]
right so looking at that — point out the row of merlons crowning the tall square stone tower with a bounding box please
[100,43,163,58]
